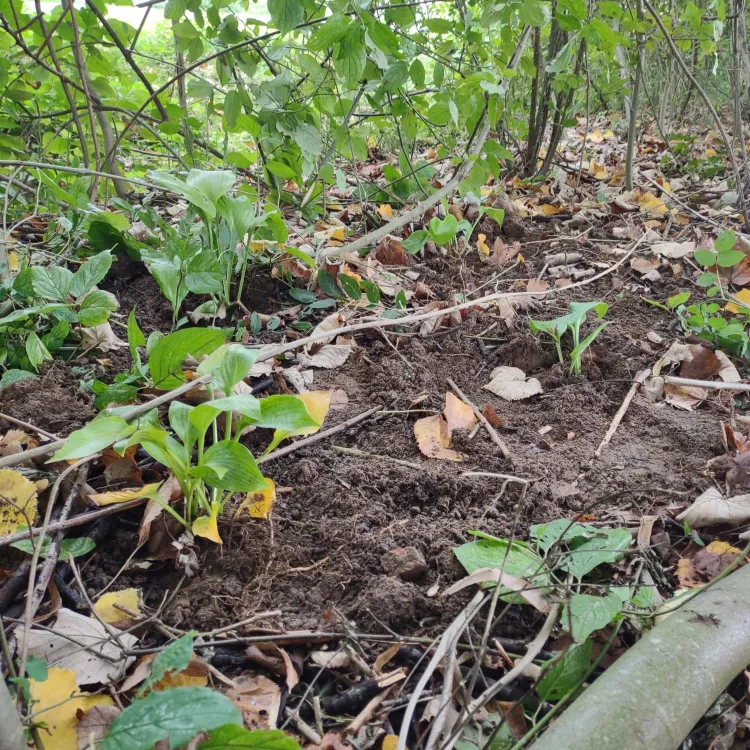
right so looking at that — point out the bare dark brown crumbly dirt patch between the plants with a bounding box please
[3,225,748,637]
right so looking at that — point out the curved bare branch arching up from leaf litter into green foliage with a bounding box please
[317,27,531,258]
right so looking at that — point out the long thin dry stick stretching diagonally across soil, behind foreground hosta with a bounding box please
[0,238,643,472]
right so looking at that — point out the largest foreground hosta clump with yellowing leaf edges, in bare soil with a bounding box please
[47,344,329,544]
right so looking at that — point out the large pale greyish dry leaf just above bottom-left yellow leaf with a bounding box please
[18,608,138,685]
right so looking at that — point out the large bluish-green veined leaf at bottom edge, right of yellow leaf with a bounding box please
[102,687,242,750]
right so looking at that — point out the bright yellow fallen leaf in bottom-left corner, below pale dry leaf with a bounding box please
[29,667,115,750]
